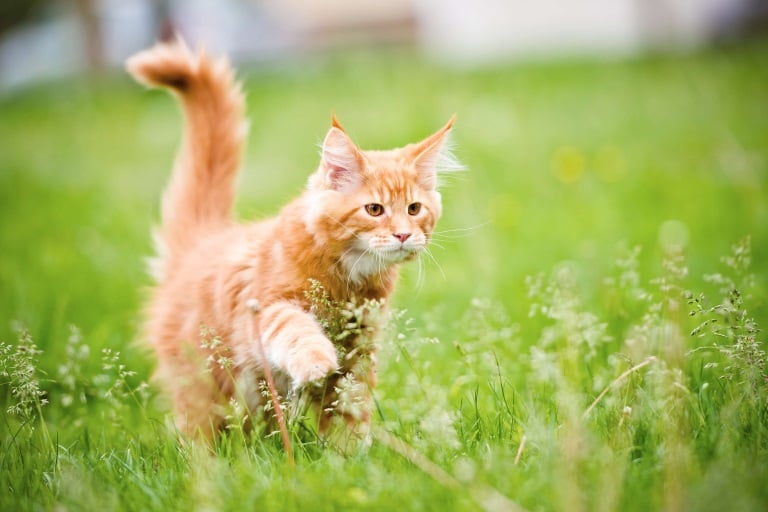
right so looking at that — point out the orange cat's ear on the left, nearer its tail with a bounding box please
[320,115,364,193]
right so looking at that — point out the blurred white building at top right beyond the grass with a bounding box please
[416,0,749,63]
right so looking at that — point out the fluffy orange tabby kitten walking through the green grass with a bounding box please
[127,41,453,438]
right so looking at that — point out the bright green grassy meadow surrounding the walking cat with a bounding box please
[0,38,768,511]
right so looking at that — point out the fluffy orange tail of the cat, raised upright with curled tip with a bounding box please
[126,39,248,277]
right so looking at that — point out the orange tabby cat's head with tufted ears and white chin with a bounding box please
[304,117,456,281]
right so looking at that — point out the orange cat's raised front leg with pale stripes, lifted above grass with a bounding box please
[259,302,339,388]
